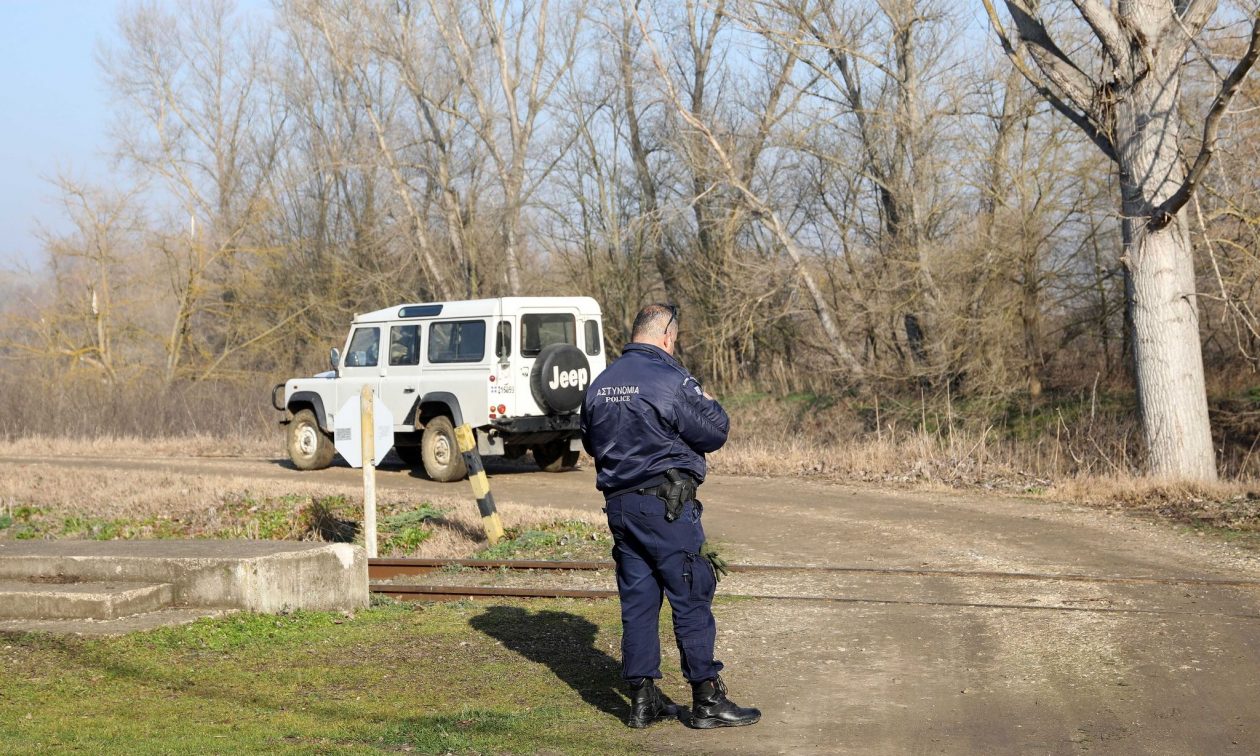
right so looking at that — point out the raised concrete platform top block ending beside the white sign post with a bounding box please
[0,541,368,612]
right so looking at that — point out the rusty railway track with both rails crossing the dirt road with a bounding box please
[368,558,1260,619]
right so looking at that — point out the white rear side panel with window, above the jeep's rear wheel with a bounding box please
[421,316,494,427]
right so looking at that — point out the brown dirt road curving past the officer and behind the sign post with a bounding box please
[12,459,1260,753]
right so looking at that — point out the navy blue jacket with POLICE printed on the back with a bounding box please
[582,343,731,494]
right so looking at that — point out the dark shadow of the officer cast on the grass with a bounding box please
[470,606,670,722]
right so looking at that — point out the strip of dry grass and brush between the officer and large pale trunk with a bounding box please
[713,394,1142,490]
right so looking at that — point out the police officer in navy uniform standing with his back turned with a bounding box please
[582,305,761,728]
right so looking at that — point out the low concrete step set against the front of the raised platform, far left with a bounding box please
[0,578,174,620]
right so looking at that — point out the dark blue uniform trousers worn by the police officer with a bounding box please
[605,493,722,682]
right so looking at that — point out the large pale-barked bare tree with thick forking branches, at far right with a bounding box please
[984,0,1260,480]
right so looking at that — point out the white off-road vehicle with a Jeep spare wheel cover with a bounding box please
[271,296,606,481]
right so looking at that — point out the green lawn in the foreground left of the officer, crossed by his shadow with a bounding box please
[0,601,645,753]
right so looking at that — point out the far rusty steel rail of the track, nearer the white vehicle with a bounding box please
[368,558,1260,588]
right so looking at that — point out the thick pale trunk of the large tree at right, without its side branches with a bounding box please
[1115,54,1216,480]
